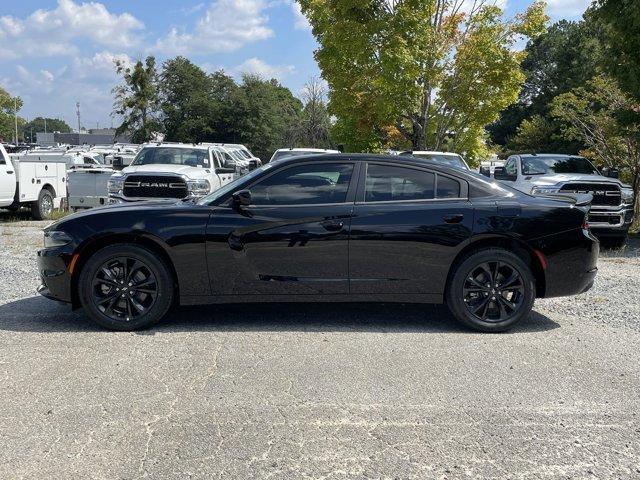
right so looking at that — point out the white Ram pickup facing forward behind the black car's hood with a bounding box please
[108,142,236,203]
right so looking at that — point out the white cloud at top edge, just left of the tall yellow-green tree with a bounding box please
[155,0,273,56]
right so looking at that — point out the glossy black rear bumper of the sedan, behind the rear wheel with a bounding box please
[531,229,600,298]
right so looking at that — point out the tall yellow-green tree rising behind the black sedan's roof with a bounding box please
[300,0,546,160]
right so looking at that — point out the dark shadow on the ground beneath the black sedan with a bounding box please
[0,297,560,335]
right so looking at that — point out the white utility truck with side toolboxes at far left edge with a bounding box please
[0,145,68,220]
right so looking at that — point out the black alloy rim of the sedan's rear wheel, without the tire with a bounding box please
[462,260,524,322]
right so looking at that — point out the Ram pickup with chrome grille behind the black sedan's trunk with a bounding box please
[494,154,633,246]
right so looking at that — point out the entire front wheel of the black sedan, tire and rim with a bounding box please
[78,243,175,331]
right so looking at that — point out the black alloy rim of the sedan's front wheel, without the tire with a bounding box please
[93,256,158,322]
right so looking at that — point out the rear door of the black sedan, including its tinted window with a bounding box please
[349,162,473,294]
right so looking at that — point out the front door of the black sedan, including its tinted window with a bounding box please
[207,161,355,295]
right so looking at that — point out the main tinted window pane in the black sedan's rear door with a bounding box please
[365,164,435,202]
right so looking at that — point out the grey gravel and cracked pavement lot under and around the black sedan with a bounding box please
[0,213,640,479]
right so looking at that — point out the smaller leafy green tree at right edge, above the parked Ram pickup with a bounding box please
[551,75,640,219]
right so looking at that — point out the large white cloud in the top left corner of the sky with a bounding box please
[0,0,144,59]
